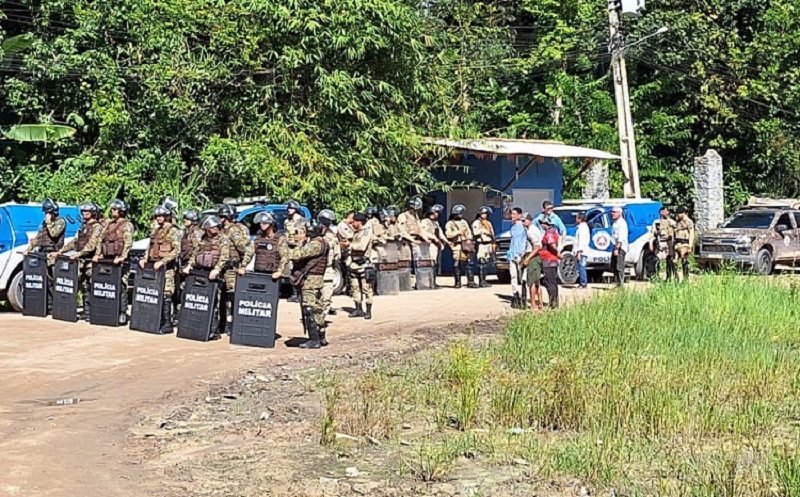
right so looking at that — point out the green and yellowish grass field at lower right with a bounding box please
[321,276,800,497]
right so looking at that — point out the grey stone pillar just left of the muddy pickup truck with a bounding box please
[692,149,725,233]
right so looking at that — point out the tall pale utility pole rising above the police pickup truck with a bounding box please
[608,0,642,198]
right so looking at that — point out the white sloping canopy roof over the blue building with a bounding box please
[426,138,621,160]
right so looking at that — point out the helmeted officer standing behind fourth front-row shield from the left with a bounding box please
[139,205,182,335]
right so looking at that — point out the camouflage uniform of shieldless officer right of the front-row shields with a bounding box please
[289,237,328,328]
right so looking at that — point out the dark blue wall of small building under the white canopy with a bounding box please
[431,154,564,273]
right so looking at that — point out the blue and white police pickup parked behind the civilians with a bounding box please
[497,198,661,285]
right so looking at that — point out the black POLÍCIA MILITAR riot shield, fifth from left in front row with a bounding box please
[178,271,217,342]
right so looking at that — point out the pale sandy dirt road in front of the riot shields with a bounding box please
[0,281,612,497]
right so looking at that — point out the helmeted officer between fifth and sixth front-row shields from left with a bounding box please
[217,205,253,335]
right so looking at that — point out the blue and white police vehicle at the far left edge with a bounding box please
[0,203,81,311]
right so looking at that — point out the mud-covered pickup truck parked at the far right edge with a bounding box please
[697,198,800,274]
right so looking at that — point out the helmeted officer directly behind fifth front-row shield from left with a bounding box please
[183,216,230,340]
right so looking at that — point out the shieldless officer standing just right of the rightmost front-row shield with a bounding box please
[289,225,328,349]
